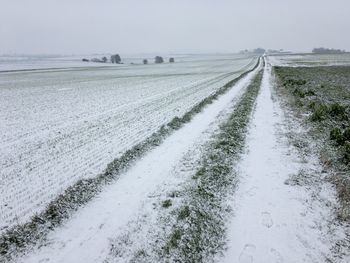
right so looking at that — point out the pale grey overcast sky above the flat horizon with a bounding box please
[0,0,350,54]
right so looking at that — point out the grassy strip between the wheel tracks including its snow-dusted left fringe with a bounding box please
[107,68,261,262]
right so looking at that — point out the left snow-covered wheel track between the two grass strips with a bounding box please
[18,58,257,263]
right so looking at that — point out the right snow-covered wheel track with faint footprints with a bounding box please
[219,60,342,263]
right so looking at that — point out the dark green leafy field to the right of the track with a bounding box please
[275,66,350,220]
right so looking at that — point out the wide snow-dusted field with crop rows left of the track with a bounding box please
[0,55,257,231]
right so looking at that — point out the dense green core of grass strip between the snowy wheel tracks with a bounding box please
[160,67,263,262]
